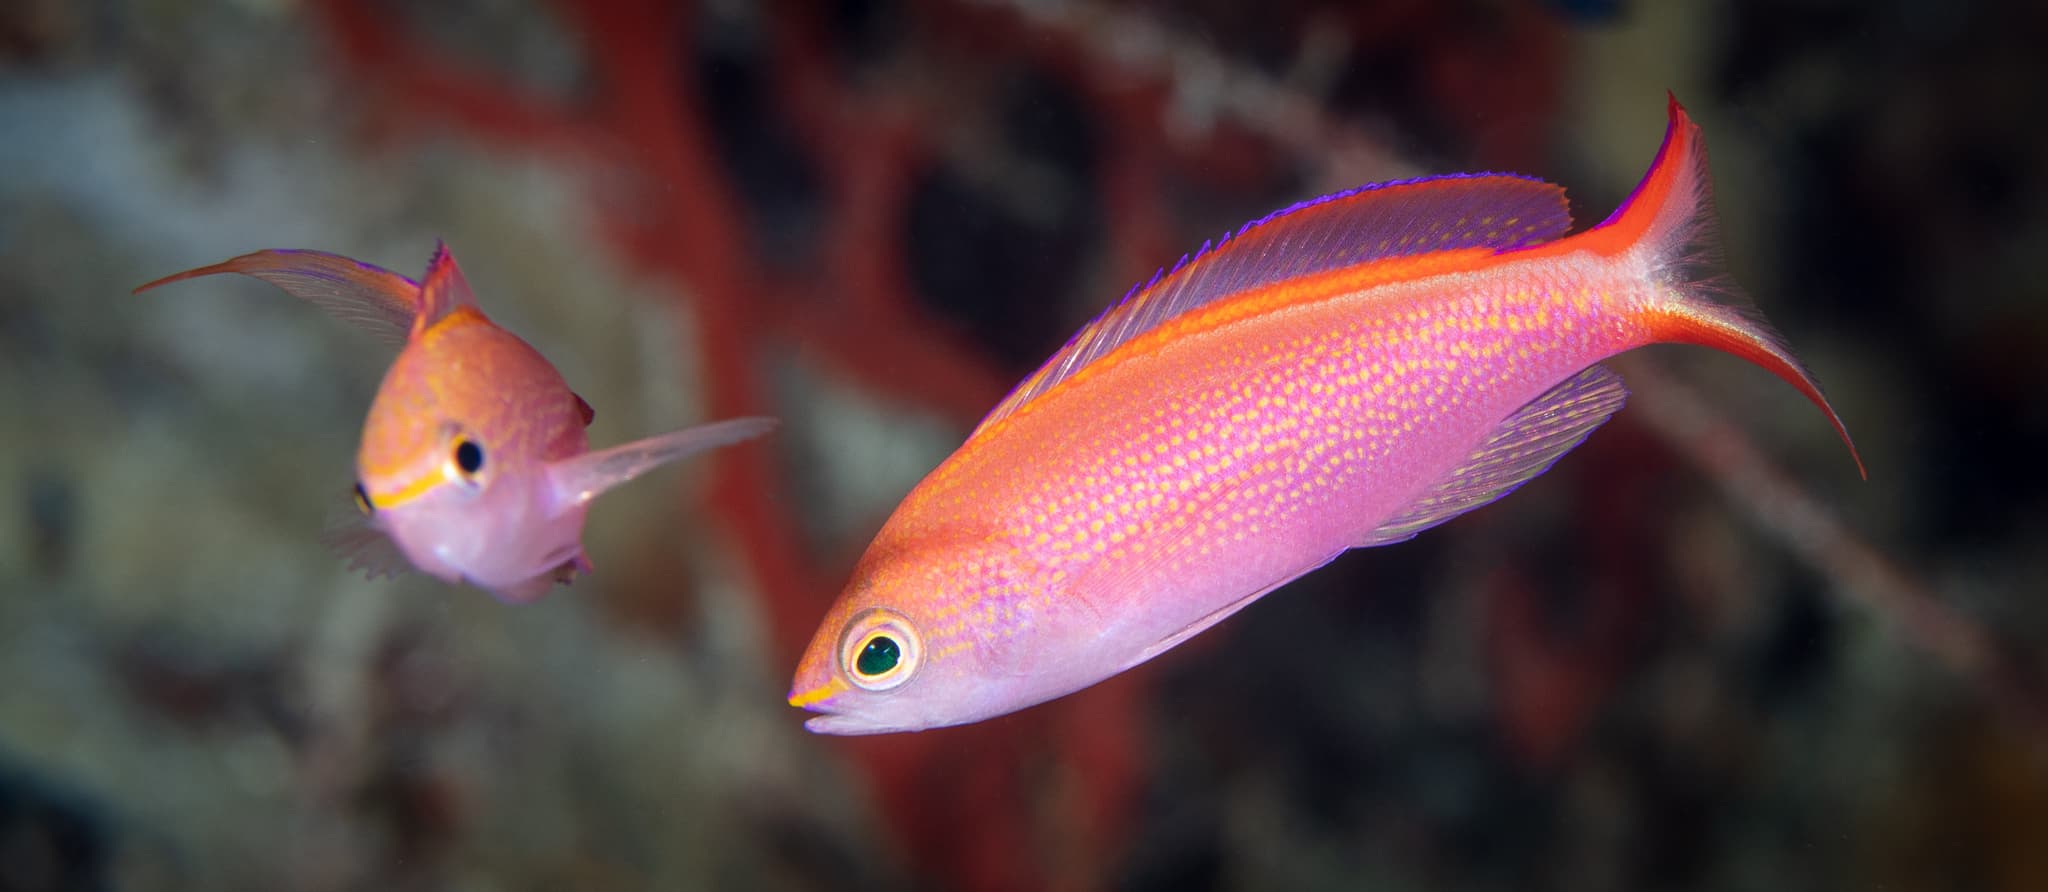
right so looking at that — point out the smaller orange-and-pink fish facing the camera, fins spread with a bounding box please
[135,243,776,604]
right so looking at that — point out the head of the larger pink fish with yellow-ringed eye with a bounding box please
[788,532,1071,734]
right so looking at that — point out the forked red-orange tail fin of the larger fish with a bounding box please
[1579,96,1870,479]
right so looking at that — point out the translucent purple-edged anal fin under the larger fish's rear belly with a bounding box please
[1358,364,1628,546]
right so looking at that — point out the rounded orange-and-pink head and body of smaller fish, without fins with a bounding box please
[356,311,588,601]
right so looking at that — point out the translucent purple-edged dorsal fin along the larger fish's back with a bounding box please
[975,174,1571,434]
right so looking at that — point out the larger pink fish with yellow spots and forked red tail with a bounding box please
[788,98,1862,734]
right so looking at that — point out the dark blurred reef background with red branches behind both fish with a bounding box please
[0,0,2048,892]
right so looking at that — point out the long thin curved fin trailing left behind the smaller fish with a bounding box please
[135,248,420,346]
